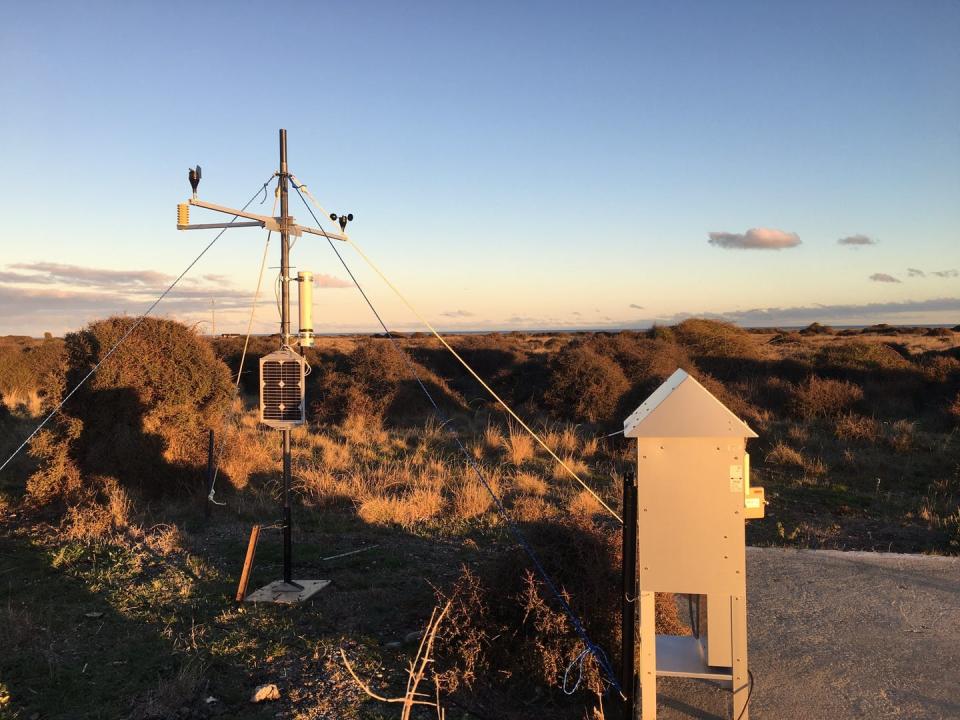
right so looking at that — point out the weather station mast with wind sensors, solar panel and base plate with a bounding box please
[177,129,353,603]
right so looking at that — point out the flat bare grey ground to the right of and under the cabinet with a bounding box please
[658,548,960,720]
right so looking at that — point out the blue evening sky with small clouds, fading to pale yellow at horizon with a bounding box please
[0,0,960,336]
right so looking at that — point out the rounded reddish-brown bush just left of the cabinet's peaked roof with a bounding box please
[544,343,630,422]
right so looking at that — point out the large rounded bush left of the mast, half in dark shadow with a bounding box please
[28,317,233,504]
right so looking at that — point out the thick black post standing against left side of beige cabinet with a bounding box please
[620,470,637,720]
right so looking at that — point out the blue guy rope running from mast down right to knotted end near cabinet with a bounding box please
[291,181,623,695]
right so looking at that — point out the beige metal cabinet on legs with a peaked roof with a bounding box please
[624,370,764,720]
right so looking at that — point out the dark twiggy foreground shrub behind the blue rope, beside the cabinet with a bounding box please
[435,521,688,704]
